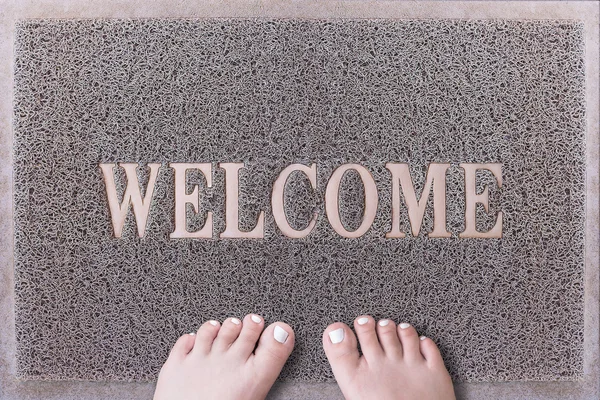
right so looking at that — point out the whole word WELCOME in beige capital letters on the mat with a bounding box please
[100,163,502,239]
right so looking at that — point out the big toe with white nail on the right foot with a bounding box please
[323,322,360,383]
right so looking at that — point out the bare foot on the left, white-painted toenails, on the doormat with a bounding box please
[154,314,294,400]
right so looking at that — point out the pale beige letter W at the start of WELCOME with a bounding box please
[100,163,160,238]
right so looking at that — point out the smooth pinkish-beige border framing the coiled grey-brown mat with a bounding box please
[0,0,600,399]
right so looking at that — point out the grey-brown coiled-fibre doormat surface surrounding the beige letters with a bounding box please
[14,19,585,381]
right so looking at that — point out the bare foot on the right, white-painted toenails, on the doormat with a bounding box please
[323,315,455,400]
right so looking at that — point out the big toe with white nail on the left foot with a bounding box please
[250,322,295,384]
